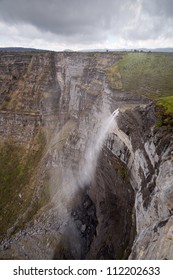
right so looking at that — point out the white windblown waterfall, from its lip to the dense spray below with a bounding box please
[48,109,119,221]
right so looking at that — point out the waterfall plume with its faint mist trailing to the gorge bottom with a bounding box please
[50,109,119,259]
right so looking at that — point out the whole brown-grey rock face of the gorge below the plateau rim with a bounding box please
[0,52,173,259]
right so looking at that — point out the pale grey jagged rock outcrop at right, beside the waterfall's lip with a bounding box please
[108,105,173,259]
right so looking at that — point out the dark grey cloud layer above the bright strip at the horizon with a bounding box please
[0,0,173,47]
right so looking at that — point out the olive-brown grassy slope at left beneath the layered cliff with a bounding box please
[0,132,45,239]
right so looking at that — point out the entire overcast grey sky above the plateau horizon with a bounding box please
[0,0,173,51]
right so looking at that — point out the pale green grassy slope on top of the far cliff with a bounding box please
[107,53,173,98]
